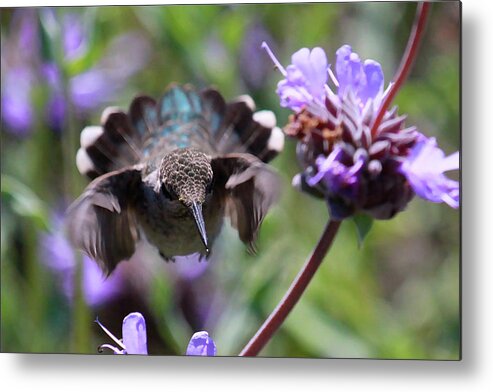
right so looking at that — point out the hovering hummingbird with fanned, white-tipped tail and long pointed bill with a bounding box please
[68,85,284,275]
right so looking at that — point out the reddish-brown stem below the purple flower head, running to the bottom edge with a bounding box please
[240,220,341,357]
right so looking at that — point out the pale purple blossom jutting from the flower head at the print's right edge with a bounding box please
[401,137,459,208]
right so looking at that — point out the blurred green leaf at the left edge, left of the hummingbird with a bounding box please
[1,175,49,229]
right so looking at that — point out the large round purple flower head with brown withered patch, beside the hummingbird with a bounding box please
[262,42,459,220]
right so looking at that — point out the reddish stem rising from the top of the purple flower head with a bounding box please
[371,2,431,137]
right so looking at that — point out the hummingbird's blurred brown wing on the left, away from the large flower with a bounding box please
[67,168,141,275]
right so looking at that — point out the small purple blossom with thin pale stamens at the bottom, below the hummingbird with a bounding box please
[96,312,147,355]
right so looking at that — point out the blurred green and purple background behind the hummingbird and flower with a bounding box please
[1,2,460,359]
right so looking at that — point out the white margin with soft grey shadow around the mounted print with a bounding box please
[0,0,493,392]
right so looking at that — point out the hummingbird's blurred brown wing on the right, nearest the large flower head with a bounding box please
[211,154,280,251]
